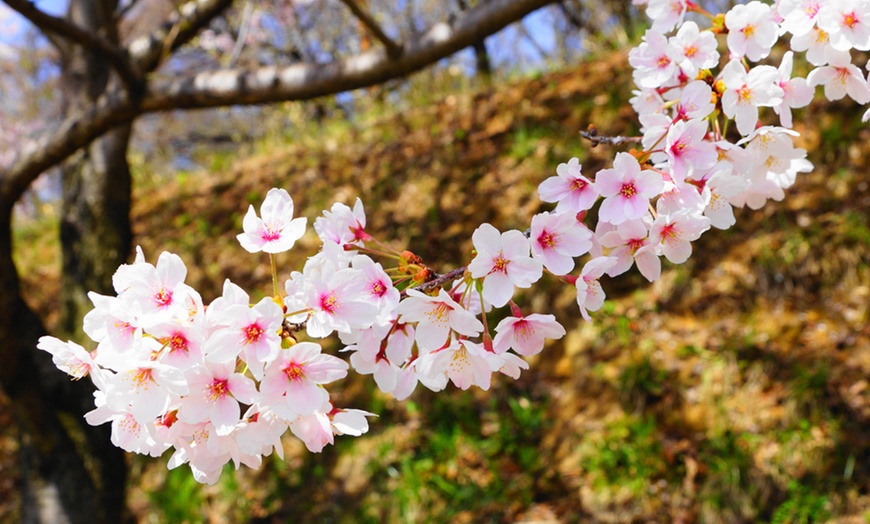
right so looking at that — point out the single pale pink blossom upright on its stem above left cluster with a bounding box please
[236,188,308,253]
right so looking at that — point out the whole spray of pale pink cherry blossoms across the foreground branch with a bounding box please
[38,0,870,482]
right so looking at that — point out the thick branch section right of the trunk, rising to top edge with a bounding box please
[142,0,552,112]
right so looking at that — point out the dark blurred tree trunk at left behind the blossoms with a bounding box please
[0,0,131,523]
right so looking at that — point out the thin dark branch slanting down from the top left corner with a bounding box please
[4,0,142,89]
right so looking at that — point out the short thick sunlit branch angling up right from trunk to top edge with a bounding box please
[127,0,233,71]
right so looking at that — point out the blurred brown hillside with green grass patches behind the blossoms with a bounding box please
[6,55,870,523]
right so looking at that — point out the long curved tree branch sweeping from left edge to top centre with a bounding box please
[0,0,552,205]
